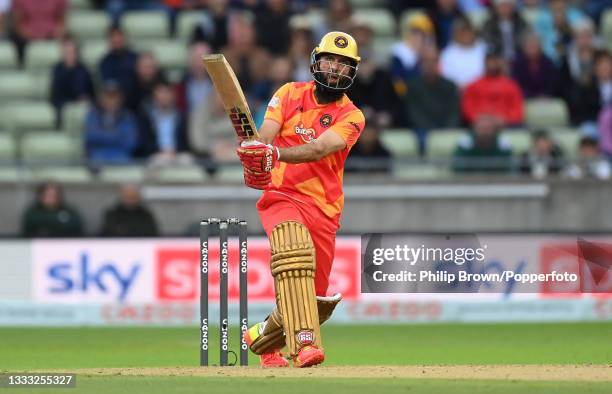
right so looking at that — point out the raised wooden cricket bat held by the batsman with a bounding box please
[202,53,259,142]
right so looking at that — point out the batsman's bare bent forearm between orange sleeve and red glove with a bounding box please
[279,130,346,163]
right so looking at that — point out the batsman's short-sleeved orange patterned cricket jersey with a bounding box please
[265,81,365,224]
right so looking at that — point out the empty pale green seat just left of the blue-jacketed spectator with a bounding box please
[21,131,82,164]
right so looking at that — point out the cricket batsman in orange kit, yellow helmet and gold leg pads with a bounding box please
[237,32,365,367]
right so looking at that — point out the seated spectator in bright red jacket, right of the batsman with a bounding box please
[461,53,523,126]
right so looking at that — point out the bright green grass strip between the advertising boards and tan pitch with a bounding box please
[0,323,612,370]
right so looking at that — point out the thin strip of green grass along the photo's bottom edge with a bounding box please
[21,377,611,394]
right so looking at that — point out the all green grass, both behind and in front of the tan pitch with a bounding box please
[0,323,612,394]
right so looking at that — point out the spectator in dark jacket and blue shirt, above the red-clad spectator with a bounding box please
[482,0,528,62]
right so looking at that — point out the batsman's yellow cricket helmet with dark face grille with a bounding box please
[310,31,361,94]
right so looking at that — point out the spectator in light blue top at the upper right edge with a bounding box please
[535,0,585,63]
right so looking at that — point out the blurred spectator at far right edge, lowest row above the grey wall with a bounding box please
[565,137,610,180]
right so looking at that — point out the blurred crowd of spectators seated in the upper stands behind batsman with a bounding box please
[0,0,612,179]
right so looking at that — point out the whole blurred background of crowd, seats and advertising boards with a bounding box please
[0,0,612,325]
